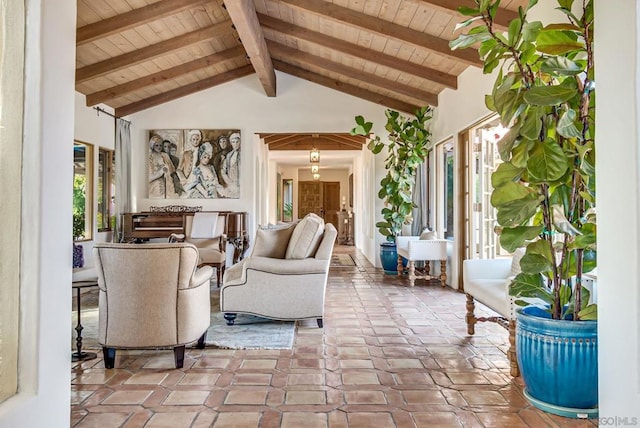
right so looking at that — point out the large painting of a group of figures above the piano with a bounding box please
[148,129,241,199]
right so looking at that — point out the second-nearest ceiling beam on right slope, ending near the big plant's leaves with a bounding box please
[280,0,482,67]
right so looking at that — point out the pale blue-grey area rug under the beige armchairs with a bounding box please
[71,286,295,352]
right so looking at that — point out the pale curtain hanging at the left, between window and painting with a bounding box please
[113,118,132,242]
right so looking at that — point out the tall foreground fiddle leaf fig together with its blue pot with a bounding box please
[450,0,598,417]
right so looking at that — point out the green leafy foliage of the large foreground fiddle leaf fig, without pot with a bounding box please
[450,0,597,320]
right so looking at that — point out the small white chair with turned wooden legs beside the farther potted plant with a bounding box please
[396,236,448,287]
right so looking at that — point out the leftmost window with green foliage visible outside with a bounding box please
[73,141,93,241]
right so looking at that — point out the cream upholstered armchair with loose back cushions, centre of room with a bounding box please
[220,214,338,327]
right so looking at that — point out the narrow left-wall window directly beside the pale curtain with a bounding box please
[96,148,116,232]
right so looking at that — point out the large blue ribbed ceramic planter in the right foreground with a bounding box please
[516,306,598,418]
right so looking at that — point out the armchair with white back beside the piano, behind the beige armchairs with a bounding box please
[169,212,227,287]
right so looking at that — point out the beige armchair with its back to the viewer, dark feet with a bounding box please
[93,243,213,368]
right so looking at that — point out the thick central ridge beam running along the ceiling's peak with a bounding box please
[224,0,276,97]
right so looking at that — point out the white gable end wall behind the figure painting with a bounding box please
[130,72,385,259]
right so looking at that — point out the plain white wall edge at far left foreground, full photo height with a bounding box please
[0,0,76,428]
